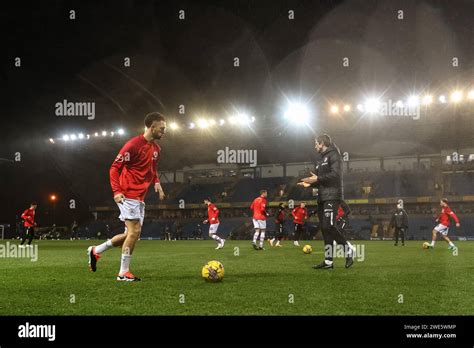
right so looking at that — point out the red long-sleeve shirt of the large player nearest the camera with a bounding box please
[110,135,161,201]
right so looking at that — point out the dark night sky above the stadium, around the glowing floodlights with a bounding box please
[0,0,474,226]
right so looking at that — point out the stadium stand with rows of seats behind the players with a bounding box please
[75,156,474,240]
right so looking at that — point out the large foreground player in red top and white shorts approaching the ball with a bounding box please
[87,112,166,282]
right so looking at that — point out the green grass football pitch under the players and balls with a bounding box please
[0,240,474,315]
